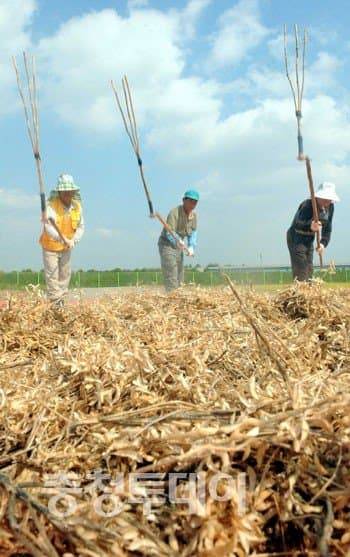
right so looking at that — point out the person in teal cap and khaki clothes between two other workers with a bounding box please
[158,190,199,292]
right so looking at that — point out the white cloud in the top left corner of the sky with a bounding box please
[0,0,36,115]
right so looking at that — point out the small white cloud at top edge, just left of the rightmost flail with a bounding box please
[210,0,269,67]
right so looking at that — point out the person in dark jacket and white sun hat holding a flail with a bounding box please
[287,182,339,281]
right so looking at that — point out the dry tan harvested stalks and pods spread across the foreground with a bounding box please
[0,282,350,557]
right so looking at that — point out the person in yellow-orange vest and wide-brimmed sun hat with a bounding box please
[40,174,84,307]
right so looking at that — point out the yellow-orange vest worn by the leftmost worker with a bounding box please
[39,198,81,251]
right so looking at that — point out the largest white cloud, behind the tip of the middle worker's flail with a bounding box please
[38,0,220,138]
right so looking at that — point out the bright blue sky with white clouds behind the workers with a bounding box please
[0,0,350,269]
